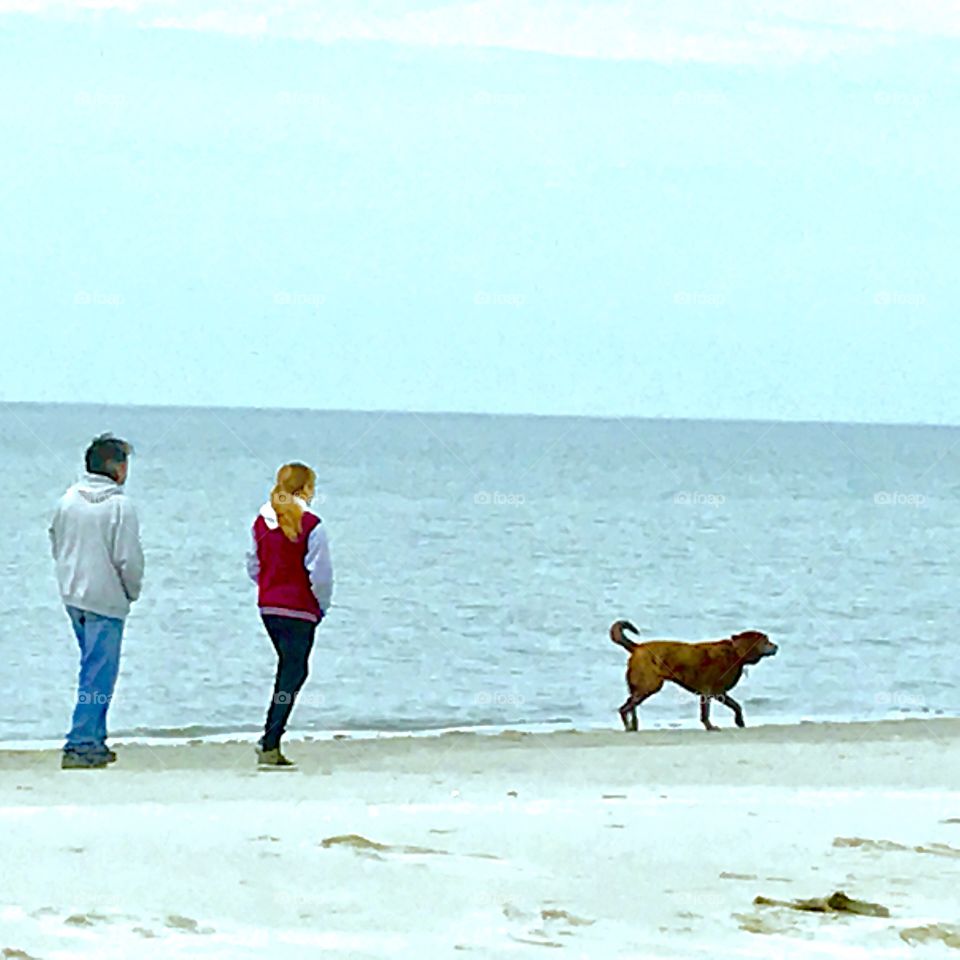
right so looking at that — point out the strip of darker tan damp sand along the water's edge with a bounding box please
[0,718,960,789]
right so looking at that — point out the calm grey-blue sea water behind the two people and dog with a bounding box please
[0,405,960,740]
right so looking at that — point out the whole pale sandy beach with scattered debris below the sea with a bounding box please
[0,719,960,960]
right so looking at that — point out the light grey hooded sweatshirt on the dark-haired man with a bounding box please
[50,473,143,619]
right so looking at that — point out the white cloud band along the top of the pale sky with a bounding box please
[0,0,960,68]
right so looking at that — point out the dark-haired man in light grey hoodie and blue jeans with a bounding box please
[50,434,143,770]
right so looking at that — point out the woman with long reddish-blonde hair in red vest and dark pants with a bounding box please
[247,463,333,767]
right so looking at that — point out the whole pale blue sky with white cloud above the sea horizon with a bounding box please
[0,0,960,424]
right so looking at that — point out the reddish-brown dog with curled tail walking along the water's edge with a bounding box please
[610,620,777,730]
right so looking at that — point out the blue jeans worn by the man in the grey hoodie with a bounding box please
[64,607,123,753]
